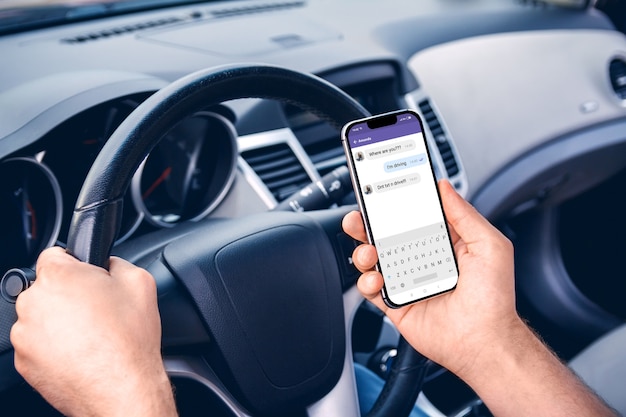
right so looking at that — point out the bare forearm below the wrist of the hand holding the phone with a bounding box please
[460,320,616,417]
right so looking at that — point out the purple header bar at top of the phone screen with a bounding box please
[348,114,422,149]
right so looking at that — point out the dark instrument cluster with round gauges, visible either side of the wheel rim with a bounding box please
[0,95,237,271]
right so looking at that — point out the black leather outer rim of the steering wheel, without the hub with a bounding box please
[66,64,425,417]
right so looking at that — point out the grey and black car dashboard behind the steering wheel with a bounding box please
[0,0,626,412]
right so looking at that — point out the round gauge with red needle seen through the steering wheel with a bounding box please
[131,112,237,227]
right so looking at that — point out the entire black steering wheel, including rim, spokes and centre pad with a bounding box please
[67,65,425,416]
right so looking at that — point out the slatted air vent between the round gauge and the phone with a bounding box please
[241,143,311,202]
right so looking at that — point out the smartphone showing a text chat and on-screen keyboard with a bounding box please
[341,110,459,308]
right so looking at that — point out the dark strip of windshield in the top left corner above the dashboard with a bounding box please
[0,0,223,33]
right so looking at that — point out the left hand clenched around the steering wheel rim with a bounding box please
[11,247,176,416]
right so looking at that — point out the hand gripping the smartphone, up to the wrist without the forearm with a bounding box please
[343,181,522,374]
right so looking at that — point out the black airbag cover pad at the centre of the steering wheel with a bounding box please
[164,213,345,415]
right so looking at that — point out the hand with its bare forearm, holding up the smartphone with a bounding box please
[343,181,615,417]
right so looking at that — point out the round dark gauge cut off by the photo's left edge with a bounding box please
[0,158,63,274]
